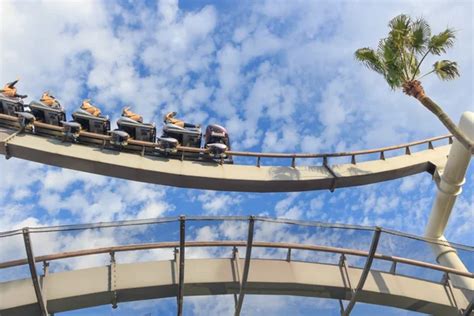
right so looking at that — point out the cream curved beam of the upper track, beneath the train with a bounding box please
[0,128,450,192]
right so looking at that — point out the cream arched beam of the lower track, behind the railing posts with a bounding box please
[0,259,474,316]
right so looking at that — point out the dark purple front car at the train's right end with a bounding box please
[204,124,233,163]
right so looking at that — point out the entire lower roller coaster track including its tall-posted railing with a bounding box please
[0,216,474,316]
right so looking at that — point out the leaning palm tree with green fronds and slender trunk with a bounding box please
[355,14,474,153]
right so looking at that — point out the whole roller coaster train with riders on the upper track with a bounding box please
[0,89,233,163]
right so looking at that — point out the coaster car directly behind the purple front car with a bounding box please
[159,123,202,154]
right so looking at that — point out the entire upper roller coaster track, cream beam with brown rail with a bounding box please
[0,114,452,192]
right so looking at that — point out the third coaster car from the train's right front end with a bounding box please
[111,116,156,146]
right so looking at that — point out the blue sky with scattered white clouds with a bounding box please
[0,0,474,315]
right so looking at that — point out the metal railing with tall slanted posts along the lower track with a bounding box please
[0,216,474,315]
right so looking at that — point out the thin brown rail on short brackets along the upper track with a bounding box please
[0,114,453,168]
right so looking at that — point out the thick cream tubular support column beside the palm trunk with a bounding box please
[425,112,474,290]
